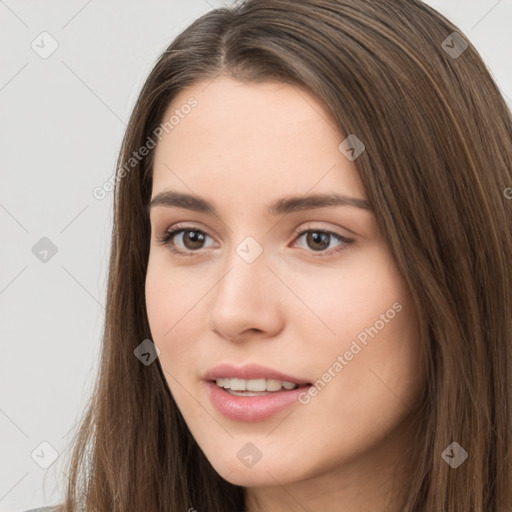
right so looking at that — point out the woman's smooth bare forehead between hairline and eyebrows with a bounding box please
[153,77,365,199]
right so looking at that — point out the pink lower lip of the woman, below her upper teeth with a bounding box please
[206,382,310,421]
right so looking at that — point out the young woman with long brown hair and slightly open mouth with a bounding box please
[29,0,512,512]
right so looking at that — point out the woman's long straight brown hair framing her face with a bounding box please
[53,0,512,512]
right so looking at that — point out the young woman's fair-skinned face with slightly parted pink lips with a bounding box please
[146,77,424,496]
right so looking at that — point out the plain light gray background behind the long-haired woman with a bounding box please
[0,0,512,512]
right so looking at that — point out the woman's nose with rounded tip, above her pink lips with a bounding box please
[207,245,284,341]
